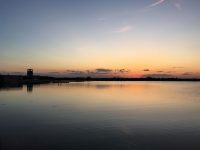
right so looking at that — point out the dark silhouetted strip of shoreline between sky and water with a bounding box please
[0,75,200,86]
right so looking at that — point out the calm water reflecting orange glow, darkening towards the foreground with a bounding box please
[0,82,200,150]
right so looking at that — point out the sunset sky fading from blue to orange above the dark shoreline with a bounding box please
[0,0,200,78]
